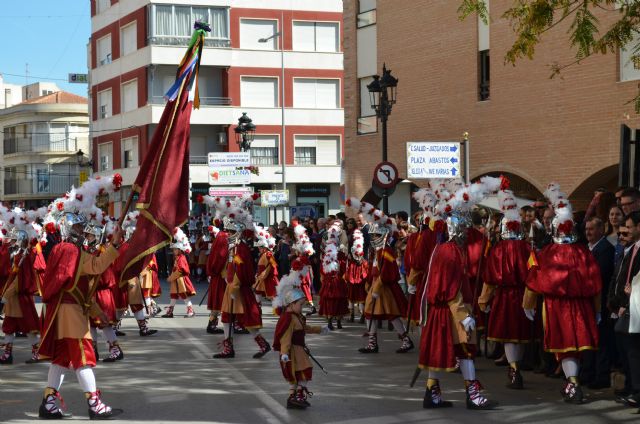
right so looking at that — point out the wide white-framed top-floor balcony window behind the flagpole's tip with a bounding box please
[149,4,230,47]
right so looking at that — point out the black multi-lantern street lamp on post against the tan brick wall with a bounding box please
[367,63,398,214]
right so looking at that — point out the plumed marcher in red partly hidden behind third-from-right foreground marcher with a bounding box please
[404,188,436,325]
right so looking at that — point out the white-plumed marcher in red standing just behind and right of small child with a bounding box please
[319,220,349,330]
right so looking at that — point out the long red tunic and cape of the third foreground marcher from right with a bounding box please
[419,241,473,371]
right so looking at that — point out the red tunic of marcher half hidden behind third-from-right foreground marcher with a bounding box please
[404,228,436,324]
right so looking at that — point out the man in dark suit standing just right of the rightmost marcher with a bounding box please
[580,216,616,389]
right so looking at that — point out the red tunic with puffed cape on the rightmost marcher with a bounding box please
[527,243,602,353]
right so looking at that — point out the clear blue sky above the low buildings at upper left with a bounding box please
[0,0,91,97]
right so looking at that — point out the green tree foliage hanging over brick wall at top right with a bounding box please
[458,0,640,113]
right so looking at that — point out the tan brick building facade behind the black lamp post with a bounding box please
[344,0,640,204]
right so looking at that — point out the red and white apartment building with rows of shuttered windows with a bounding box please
[89,0,344,224]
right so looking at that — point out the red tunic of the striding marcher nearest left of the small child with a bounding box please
[222,243,262,329]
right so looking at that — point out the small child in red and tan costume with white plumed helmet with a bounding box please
[273,265,329,409]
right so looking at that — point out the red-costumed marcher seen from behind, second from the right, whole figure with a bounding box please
[478,190,531,389]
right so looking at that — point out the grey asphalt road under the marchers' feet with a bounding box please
[0,285,640,424]
